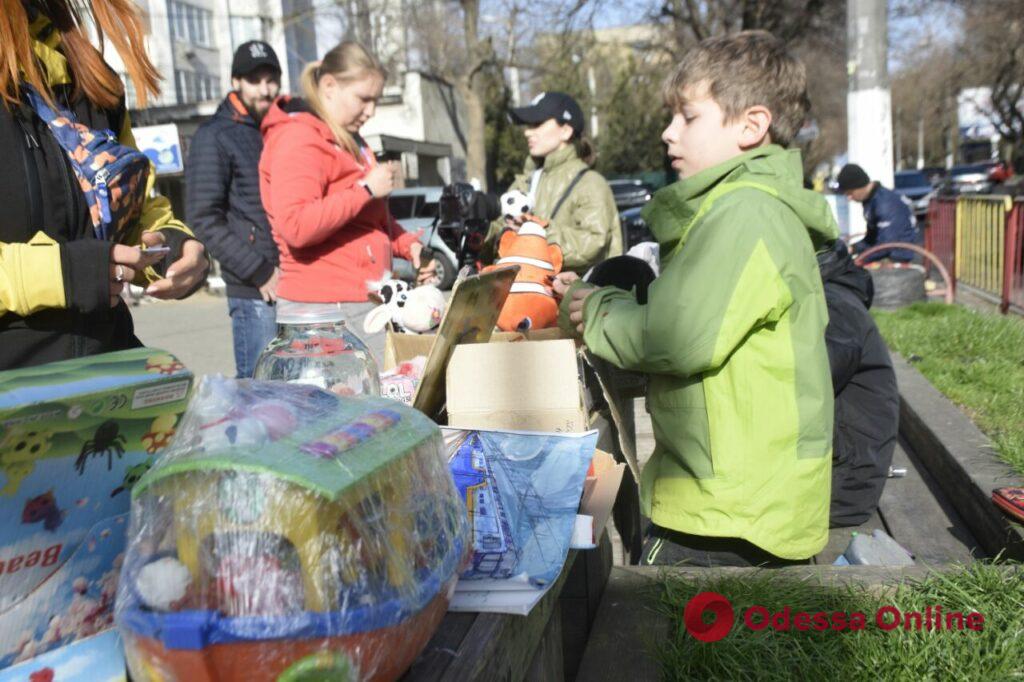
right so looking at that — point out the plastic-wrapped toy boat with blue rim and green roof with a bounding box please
[116,378,469,682]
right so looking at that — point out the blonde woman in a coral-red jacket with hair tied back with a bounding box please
[260,42,427,353]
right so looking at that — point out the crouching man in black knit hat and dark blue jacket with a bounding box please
[837,164,920,263]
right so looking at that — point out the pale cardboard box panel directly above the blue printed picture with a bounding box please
[446,339,587,433]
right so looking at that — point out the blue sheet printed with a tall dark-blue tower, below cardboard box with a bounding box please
[443,429,597,589]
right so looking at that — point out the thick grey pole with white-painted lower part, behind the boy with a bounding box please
[846,0,893,235]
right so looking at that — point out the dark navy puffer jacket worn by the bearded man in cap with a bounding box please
[185,92,279,298]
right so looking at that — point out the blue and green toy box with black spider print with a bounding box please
[0,348,193,669]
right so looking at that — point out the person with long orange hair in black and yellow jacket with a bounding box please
[0,0,209,370]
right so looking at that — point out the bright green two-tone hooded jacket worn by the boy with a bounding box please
[561,145,839,559]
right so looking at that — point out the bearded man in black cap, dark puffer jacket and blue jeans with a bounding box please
[185,40,281,379]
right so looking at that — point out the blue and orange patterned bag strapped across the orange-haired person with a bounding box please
[22,84,151,242]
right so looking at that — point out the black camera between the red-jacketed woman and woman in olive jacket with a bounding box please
[437,182,501,270]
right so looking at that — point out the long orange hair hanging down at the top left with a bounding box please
[0,0,160,109]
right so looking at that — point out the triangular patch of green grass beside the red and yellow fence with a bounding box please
[874,303,1024,473]
